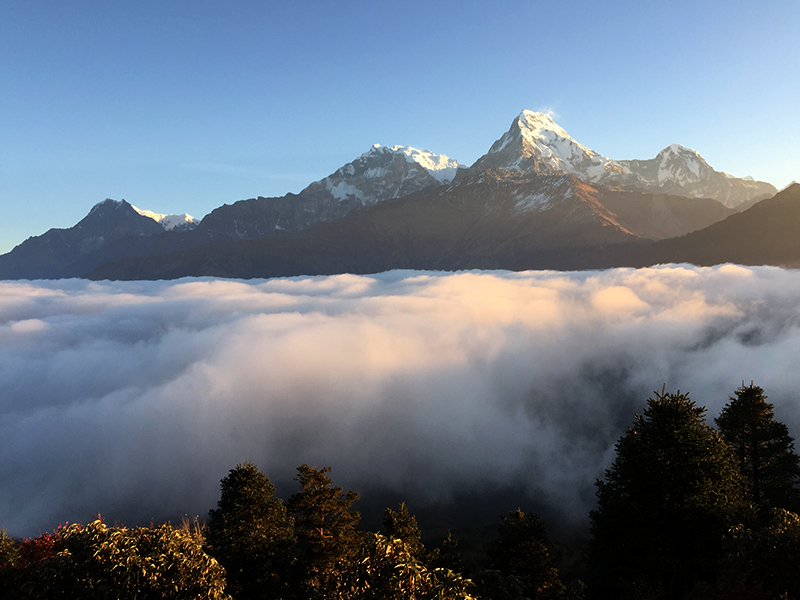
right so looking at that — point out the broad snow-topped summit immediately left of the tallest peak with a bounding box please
[299,144,460,206]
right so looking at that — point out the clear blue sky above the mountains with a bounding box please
[0,0,800,252]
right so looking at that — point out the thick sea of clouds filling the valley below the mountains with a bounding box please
[0,265,800,536]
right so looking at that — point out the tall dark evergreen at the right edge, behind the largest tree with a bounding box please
[715,382,800,512]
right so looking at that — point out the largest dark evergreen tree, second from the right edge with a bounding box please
[588,392,750,598]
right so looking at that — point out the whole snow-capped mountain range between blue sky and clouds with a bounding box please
[0,111,788,279]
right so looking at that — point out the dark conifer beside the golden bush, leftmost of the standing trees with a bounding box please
[206,462,295,599]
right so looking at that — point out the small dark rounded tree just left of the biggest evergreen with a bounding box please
[489,508,566,600]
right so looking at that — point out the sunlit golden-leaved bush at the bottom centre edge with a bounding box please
[336,534,473,600]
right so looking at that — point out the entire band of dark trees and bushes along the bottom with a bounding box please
[0,382,800,600]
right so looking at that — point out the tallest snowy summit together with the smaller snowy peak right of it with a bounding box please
[472,110,777,207]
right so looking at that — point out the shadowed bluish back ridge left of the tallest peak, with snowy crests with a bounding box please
[0,145,460,279]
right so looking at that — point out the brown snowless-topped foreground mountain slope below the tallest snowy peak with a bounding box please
[84,169,732,279]
